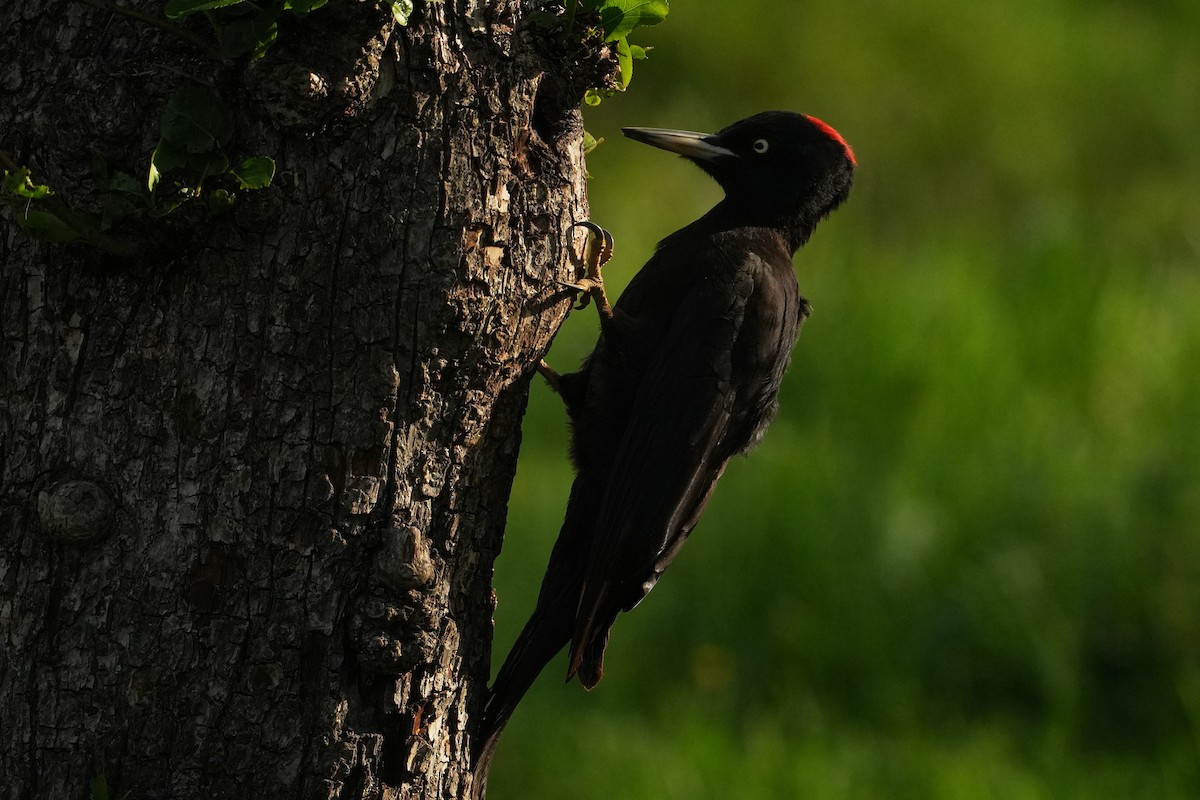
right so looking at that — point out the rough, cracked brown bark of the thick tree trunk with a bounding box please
[0,0,610,799]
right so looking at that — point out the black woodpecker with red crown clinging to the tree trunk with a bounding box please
[475,112,856,796]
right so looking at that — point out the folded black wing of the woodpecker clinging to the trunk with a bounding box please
[570,254,768,686]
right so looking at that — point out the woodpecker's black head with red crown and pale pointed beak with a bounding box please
[622,112,856,246]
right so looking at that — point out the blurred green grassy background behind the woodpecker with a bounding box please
[490,0,1200,800]
